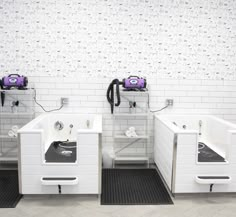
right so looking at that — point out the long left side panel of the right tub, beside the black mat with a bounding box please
[154,118,174,189]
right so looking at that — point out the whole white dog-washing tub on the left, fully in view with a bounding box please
[18,113,102,194]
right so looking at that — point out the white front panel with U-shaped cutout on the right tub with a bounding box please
[175,134,236,193]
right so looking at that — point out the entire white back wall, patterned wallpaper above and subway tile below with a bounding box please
[0,0,236,159]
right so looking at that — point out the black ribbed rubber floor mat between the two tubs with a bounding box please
[101,169,173,205]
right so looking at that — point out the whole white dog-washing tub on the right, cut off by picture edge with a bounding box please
[154,115,236,194]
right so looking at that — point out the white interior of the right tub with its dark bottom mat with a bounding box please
[159,115,236,163]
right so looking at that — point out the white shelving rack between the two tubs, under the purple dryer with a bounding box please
[113,91,150,167]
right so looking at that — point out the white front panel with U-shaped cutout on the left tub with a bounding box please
[20,133,101,194]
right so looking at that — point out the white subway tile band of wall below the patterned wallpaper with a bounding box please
[7,76,236,157]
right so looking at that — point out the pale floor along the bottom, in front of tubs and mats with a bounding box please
[0,194,236,217]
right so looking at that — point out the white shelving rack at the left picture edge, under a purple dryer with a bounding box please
[0,88,35,162]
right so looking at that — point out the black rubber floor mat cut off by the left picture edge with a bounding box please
[0,170,22,208]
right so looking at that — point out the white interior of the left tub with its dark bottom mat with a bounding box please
[32,114,94,163]
